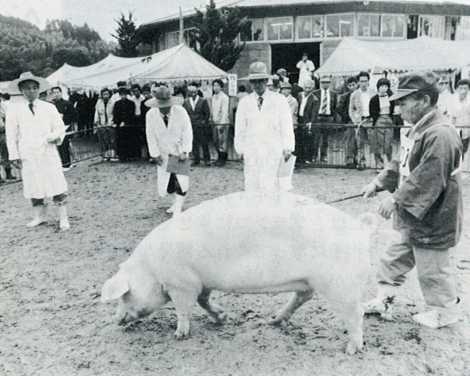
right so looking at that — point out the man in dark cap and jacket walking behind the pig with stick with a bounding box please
[363,75,463,328]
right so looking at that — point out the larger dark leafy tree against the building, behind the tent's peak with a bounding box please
[189,0,251,71]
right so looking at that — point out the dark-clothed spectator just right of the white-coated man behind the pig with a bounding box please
[295,78,320,165]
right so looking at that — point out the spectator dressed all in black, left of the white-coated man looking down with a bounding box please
[113,87,136,161]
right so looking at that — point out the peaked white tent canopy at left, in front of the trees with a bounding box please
[48,44,227,88]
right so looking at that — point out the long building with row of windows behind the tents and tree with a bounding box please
[139,0,470,81]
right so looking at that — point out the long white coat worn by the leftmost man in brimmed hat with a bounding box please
[6,100,67,199]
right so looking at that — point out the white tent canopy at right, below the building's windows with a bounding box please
[316,37,470,76]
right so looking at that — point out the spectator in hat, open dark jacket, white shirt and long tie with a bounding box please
[313,76,338,163]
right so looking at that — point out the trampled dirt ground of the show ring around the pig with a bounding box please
[0,162,470,376]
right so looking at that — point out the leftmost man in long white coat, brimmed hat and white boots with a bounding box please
[5,72,70,230]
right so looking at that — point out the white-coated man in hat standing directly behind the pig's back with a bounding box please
[234,62,295,193]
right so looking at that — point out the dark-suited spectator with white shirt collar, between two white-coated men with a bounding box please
[183,83,211,166]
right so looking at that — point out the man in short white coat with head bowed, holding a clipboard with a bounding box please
[146,86,193,215]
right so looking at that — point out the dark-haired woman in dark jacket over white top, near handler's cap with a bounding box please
[369,78,395,169]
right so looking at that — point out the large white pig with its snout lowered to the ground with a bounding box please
[101,192,371,354]
